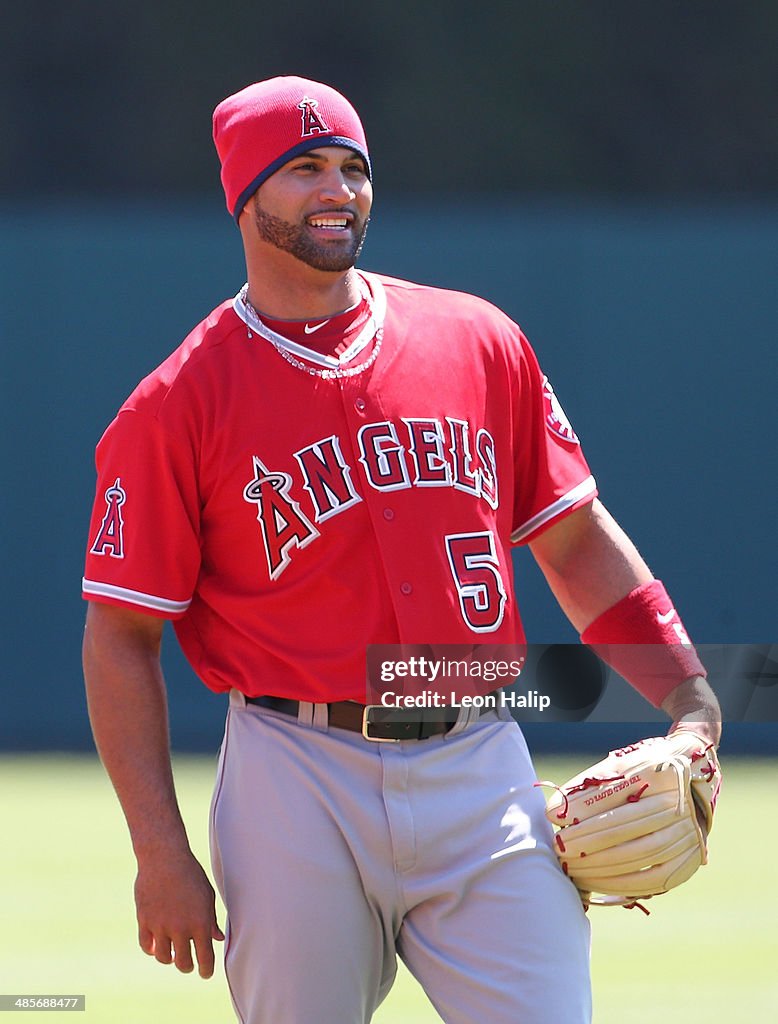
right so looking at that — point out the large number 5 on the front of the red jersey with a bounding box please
[445,530,508,633]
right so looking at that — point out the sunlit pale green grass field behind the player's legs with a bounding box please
[0,757,778,1024]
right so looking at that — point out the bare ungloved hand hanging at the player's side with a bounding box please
[135,851,224,978]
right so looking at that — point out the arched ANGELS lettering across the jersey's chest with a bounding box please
[244,417,498,580]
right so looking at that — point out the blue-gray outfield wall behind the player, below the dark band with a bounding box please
[0,195,778,750]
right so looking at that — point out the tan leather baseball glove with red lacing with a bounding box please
[541,730,722,912]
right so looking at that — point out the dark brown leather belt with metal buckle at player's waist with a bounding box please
[246,696,493,743]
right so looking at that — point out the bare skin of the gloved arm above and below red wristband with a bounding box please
[529,499,722,745]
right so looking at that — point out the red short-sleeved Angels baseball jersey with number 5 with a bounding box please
[83,273,597,701]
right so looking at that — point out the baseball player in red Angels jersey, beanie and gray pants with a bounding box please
[83,77,719,1024]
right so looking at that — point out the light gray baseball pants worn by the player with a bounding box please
[206,691,592,1024]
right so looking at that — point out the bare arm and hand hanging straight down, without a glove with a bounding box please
[83,602,224,978]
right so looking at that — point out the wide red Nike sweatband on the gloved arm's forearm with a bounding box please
[580,580,706,708]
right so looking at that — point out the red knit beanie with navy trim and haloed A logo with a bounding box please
[213,77,372,221]
